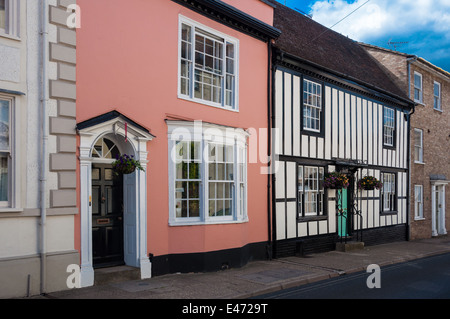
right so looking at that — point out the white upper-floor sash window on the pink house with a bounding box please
[178,17,238,110]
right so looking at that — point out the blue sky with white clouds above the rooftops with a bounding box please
[277,0,450,72]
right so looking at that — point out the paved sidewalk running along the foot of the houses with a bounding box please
[30,235,450,300]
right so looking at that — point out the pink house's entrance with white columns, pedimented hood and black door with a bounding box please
[77,111,155,287]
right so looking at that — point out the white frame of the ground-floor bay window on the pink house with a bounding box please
[168,121,248,226]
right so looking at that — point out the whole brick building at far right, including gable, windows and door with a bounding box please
[362,44,450,239]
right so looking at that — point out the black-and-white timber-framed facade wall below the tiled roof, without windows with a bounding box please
[271,49,412,257]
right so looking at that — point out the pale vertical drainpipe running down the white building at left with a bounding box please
[39,0,48,294]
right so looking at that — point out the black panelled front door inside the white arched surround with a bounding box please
[92,164,124,268]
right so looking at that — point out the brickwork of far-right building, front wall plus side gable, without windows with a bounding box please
[363,45,450,239]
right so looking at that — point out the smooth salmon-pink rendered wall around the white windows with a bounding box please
[77,0,268,256]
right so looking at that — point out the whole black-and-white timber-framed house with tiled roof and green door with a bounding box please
[271,3,413,257]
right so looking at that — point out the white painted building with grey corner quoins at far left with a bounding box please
[0,0,79,298]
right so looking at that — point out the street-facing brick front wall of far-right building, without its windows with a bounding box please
[410,62,450,239]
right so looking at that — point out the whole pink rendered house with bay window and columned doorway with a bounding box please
[75,0,279,286]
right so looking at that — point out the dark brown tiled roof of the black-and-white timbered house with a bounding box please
[267,0,409,101]
